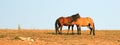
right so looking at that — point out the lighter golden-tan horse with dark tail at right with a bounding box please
[72,17,95,35]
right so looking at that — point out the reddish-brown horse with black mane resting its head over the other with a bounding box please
[55,13,80,34]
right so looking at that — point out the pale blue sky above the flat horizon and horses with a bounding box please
[0,0,120,29]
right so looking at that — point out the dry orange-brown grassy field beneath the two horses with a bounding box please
[0,29,120,45]
